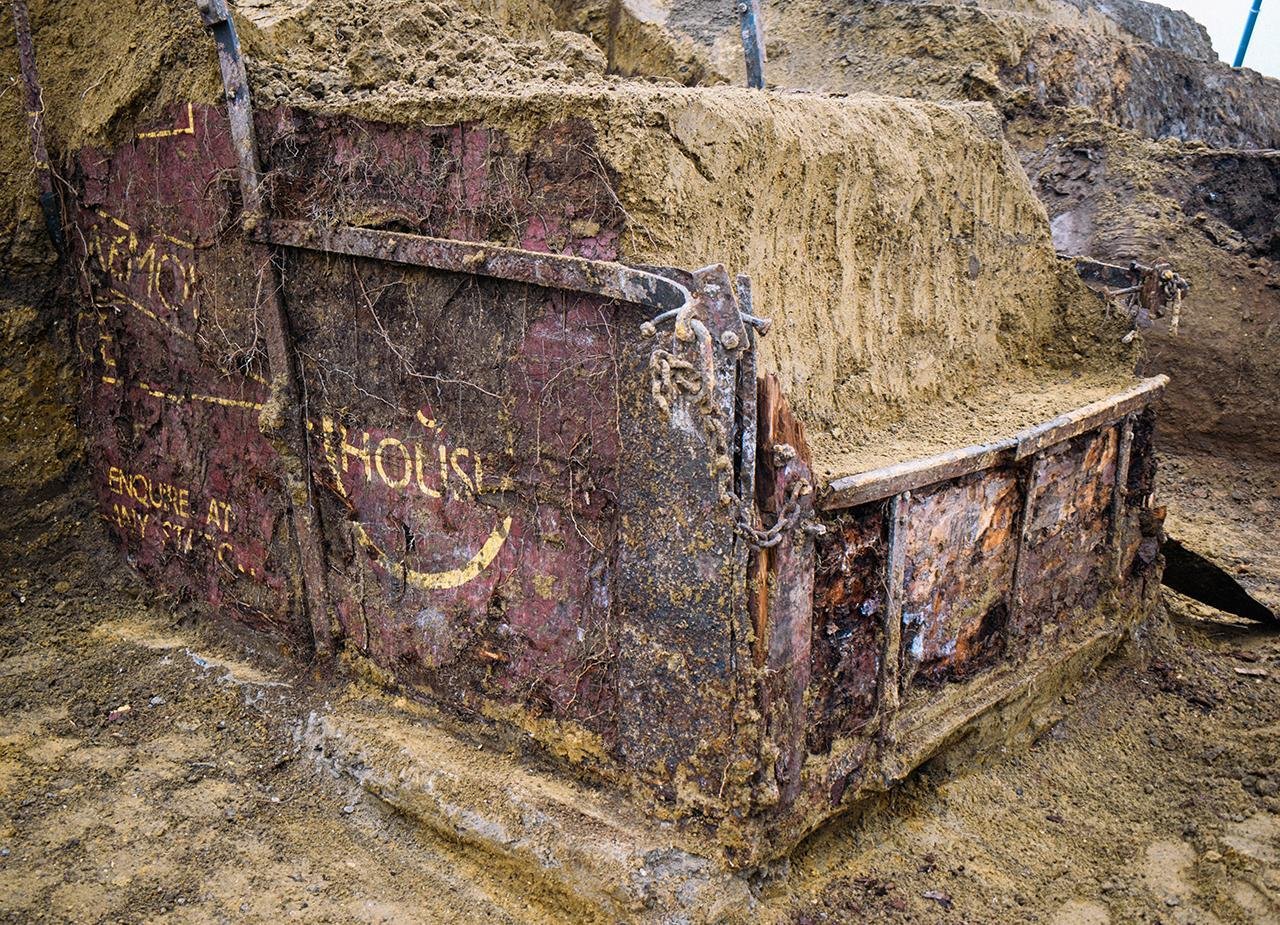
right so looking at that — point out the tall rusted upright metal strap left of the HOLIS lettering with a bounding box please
[196,0,334,658]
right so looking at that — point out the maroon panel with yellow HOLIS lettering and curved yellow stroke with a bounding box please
[295,255,624,738]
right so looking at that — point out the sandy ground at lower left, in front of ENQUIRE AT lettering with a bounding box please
[0,504,588,922]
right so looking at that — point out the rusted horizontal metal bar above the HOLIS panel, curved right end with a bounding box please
[256,219,691,311]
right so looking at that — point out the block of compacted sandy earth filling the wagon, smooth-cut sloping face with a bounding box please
[259,82,1132,439]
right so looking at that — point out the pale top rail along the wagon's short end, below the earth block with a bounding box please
[818,376,1169,510]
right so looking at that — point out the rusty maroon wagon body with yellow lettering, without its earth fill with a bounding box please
[69,63,1162,866]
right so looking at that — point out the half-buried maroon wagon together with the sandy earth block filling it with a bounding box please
[69,88,1158,866]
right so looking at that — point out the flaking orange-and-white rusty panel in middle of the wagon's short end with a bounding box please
[902,467,1021,686]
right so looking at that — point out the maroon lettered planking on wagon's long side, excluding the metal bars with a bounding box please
[64,99,746,793]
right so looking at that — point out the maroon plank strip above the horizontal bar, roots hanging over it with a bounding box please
[257,109,626,260]
